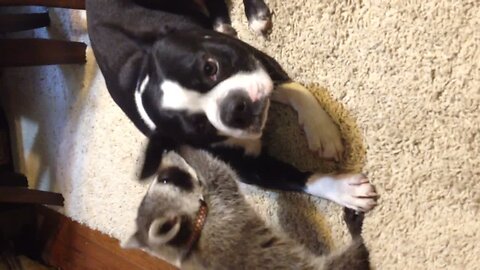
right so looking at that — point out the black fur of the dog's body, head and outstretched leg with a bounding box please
[86,0,376,211]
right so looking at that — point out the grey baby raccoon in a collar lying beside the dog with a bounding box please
[123,147,370,269]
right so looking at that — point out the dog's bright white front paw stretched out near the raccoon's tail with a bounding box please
[306,174,378,212]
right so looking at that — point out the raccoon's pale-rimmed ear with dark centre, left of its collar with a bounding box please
[148,216,181,245]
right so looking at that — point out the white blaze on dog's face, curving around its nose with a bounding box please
[160,67,273,138]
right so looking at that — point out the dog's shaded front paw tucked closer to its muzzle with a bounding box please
[298,103,344,161]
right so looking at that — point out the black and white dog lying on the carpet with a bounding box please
[86,0,377,211]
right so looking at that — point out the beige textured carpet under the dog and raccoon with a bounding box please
[1,0,480,269]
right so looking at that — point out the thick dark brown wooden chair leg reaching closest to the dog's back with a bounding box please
[0,39,87,67]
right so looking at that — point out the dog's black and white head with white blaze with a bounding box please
[136,31,273,138]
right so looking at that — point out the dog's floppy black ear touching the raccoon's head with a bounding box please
[140,132,175,180]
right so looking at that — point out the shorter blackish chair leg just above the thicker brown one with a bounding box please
[0,12,50,33]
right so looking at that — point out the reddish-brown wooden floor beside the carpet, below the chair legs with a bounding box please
[38,207,176,270]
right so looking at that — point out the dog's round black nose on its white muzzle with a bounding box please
[220,91,256,128]
